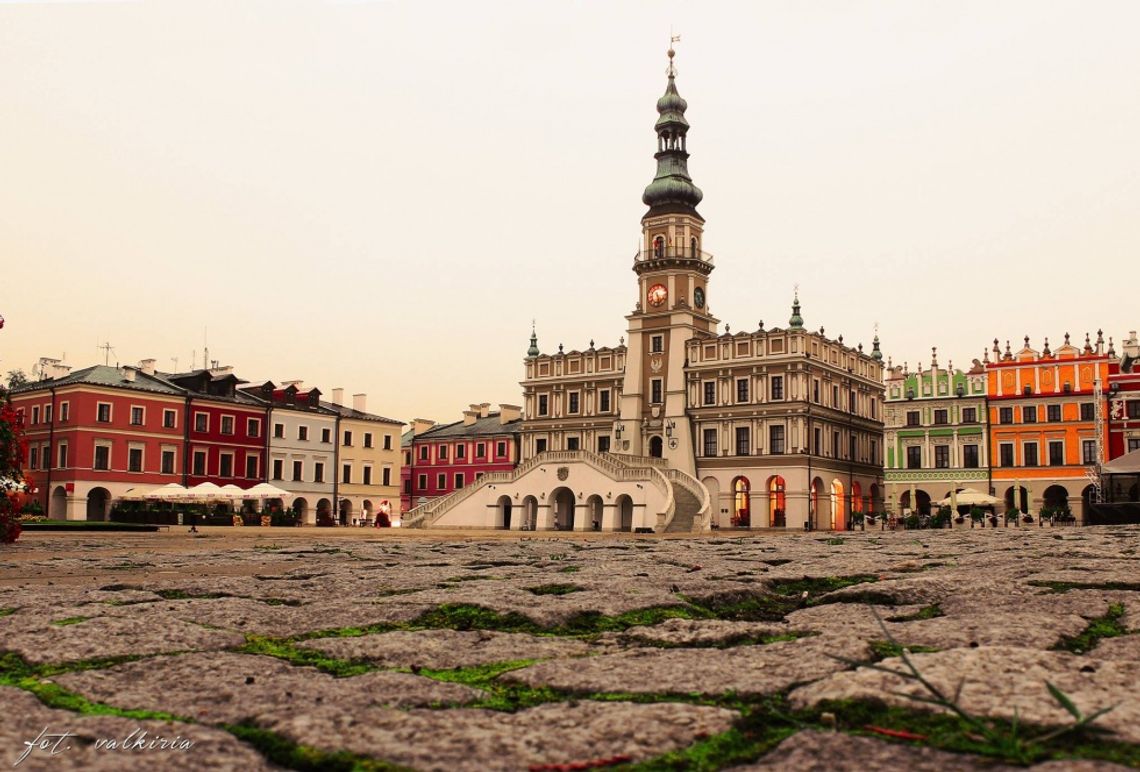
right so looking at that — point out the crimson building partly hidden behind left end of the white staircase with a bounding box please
[400,403,522,512]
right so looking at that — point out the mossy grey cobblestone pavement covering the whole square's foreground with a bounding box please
[0,526,1140,771]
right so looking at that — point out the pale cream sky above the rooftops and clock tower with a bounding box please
[0,0,1140,421]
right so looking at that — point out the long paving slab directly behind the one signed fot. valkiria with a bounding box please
[52,652,482,724]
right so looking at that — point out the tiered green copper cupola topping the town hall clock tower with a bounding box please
[642,48,705,217]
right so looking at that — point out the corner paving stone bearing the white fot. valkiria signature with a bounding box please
[0,686,279,772]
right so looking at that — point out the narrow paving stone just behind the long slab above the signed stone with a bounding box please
[299,629,595,669]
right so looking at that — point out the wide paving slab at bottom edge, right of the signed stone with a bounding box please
[266,701,736,771]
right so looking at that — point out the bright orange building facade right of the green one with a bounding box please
[986,333,1114,520]
